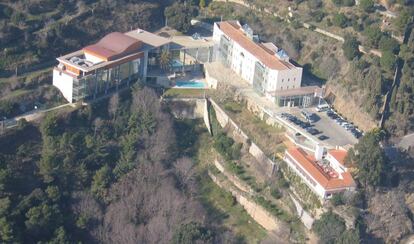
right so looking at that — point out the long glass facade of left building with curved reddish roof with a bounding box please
[73,59,143,101]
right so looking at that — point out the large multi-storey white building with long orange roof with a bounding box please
[213,21,317,107]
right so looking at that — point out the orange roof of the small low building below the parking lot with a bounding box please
[286,147,356,190]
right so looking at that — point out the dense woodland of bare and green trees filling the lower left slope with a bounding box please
[0,86,246,243]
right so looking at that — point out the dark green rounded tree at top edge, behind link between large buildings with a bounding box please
[164,2,197,33]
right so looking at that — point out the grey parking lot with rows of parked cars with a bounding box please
[278,107,358,146]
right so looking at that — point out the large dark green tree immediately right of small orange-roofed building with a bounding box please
[348,130,387,188]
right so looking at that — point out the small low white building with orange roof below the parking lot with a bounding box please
[284,147,356,199]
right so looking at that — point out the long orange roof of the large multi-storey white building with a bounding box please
[217,21,296,70]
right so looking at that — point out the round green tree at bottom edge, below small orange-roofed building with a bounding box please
[312,211,346,244]
